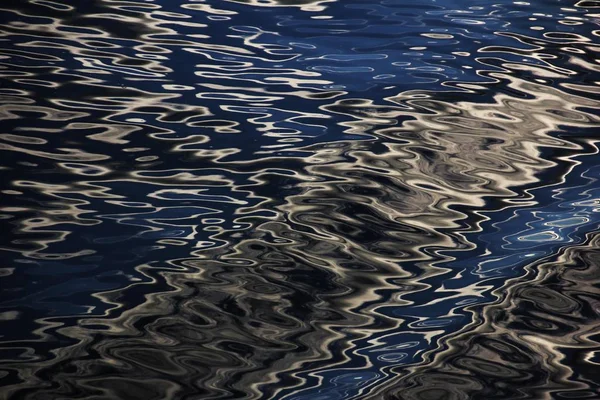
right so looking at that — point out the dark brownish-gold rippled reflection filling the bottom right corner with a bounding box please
[376,233,600,400]
